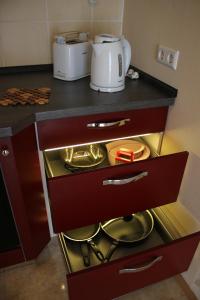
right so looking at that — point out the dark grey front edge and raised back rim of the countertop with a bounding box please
[0,65,177,138]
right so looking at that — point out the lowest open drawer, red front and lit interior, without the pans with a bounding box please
[59,202,200,300]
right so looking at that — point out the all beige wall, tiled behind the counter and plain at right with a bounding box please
[0,0,200,299]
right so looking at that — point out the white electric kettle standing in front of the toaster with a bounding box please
[90,34,131,92]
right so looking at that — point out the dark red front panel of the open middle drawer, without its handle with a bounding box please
[49,152,188,232]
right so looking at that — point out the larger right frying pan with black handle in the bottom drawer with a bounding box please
[101,210,154,261]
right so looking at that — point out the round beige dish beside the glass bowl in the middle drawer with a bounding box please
[106,140,150,166]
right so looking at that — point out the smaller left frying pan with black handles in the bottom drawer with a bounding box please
[64,224,104,267]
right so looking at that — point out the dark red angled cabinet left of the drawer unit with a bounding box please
[0,125,50,267]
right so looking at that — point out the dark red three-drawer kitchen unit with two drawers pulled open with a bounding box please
[37,108,200,300]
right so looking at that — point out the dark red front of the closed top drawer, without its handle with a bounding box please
[37,107,168,150]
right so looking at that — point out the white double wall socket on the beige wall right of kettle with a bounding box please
[157,45,179,70]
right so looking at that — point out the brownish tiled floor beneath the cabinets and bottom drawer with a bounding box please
[0,238,195,300]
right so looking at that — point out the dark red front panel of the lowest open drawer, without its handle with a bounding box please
[67,233,200,300]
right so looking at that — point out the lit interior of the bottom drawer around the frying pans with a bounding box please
[59,202,200,273]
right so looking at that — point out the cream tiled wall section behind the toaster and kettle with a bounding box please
[0,0,124,67]
